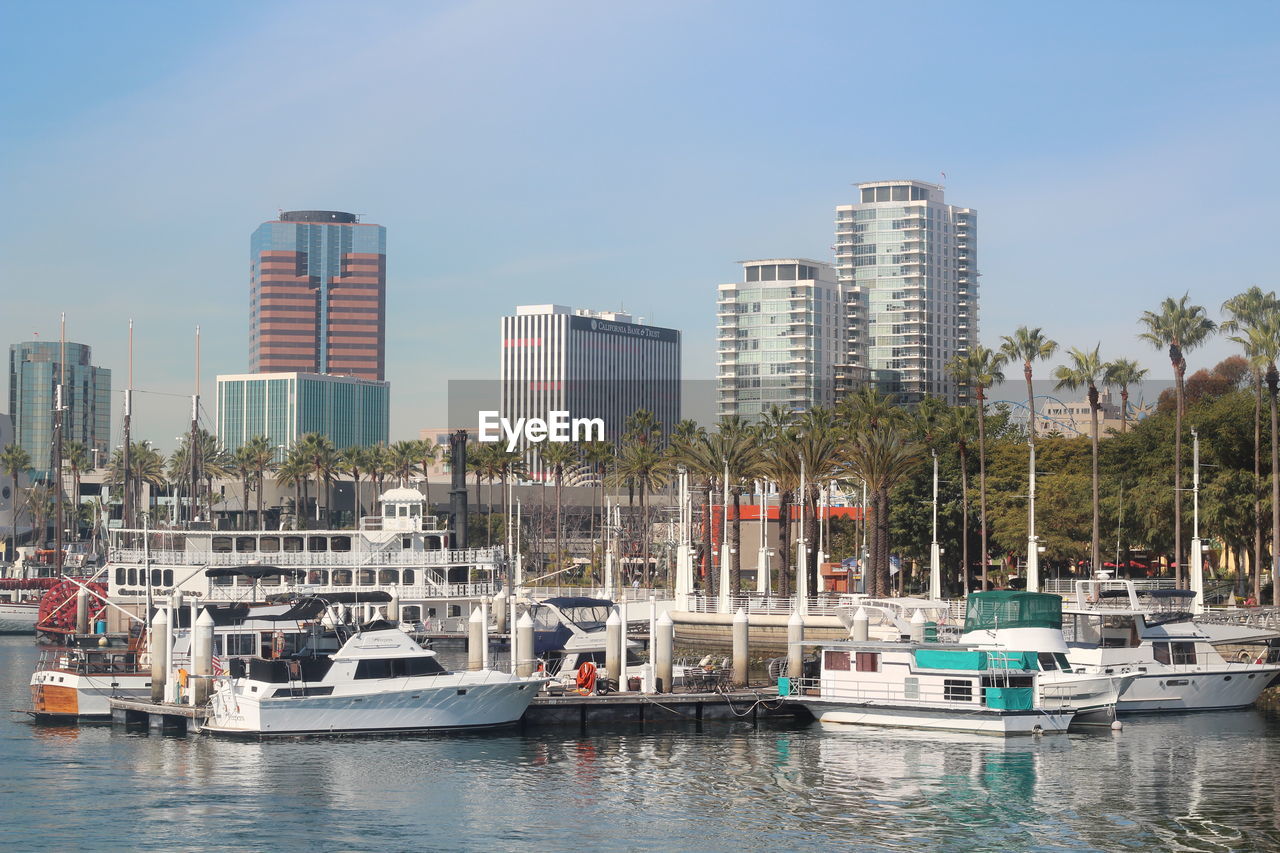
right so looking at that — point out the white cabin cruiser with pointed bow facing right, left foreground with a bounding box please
[202,624,547,735]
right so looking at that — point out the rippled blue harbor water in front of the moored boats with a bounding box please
[0,637,1280,852]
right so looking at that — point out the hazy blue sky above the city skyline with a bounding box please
[0,0,1280,447]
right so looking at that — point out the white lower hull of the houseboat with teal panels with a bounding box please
[800,699,1074,736]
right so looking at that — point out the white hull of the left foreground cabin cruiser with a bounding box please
[204,679,543,735]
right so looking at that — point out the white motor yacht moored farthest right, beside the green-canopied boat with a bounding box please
[1062,580,1280,713]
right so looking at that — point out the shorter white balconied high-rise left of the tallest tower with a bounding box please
[717,257,845,420]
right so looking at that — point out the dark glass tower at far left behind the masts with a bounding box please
[9,341,111,479]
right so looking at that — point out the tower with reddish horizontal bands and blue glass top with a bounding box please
[248,210,387,380]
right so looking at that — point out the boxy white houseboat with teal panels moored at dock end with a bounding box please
[778,642,1075,736]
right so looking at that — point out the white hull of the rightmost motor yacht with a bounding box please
[1116,665,1280,713]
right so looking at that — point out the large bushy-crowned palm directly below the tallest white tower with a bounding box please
[845,423,924,596]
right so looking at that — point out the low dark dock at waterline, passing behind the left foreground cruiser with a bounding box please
[110,688,808,734]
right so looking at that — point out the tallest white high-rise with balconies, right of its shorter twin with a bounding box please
[836,181,978,401]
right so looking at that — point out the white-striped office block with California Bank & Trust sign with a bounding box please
[499,305,680,473]
